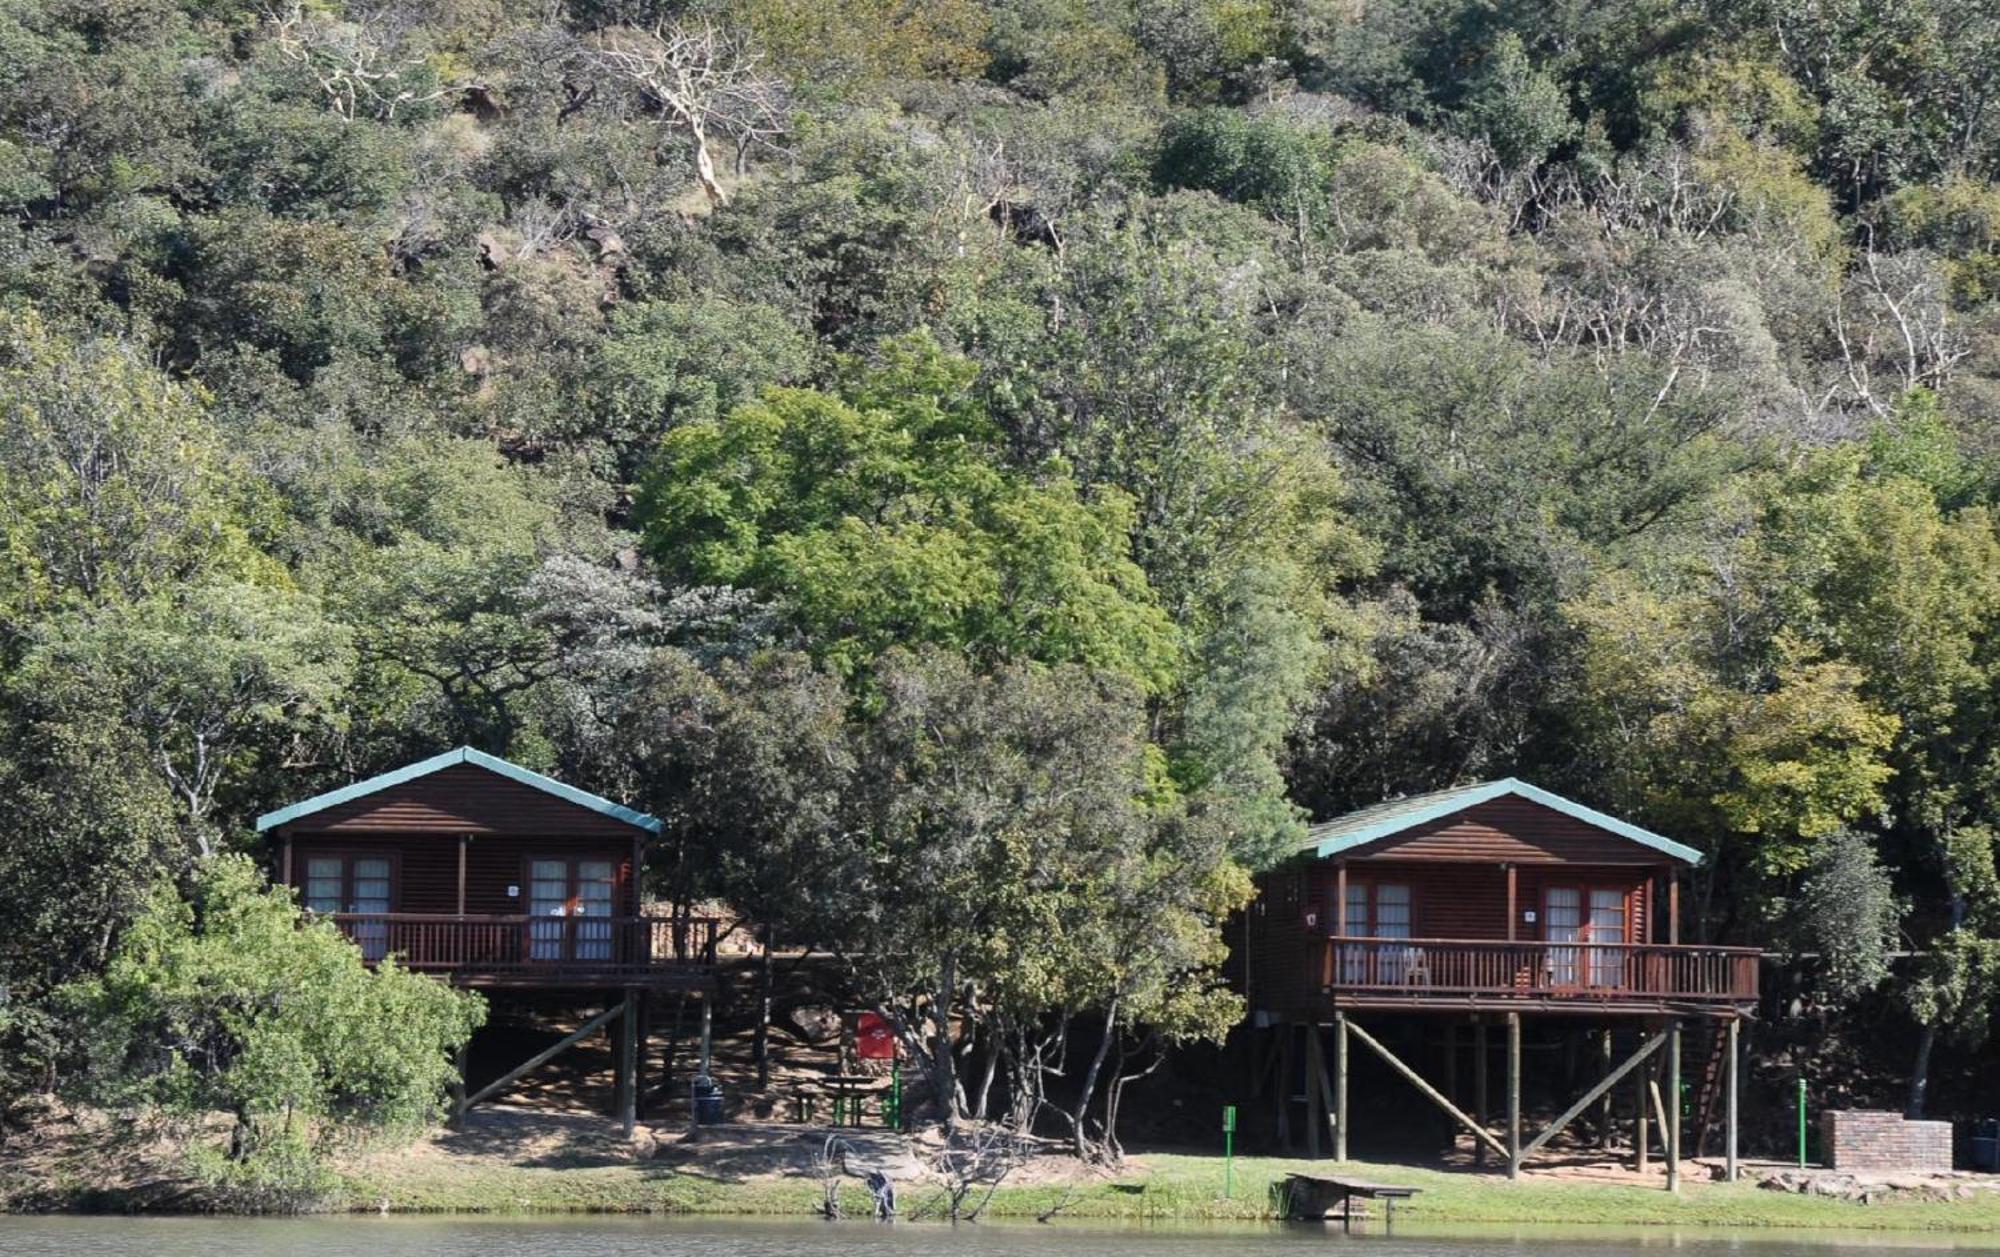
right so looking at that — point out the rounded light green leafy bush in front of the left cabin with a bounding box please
[60,855,486,1203]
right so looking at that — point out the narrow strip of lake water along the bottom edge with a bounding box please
[0,1215,2000,1257]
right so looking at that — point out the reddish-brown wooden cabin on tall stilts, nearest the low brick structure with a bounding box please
[1232,779,1758,1189]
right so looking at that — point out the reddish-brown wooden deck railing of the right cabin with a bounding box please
[1320,937,1758,1003]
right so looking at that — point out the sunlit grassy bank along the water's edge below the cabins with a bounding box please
[15,1111,2000,1231]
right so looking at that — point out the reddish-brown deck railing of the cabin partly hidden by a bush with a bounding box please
[332,913,718,983]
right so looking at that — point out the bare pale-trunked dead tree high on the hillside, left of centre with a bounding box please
[590,18,786,204]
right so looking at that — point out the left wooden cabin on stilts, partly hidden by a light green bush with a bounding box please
[258,747,716,1135]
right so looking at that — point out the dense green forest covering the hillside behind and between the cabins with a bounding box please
[0,0,2000,1184]
